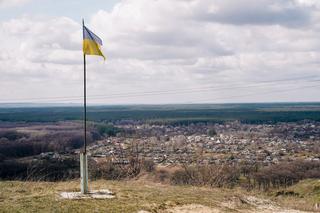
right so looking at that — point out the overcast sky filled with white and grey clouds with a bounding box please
[0,0,320,104]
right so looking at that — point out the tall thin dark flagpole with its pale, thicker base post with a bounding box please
[80,19,88,194]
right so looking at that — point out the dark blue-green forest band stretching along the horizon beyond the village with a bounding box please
[0,103,320,125]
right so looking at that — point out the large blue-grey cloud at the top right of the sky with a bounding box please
[189,0,310,26]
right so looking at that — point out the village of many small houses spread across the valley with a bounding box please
[88,121,320,166]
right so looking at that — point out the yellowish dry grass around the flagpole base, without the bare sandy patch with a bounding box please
[0,181,246,212]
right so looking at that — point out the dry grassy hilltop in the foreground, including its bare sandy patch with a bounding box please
[0,180,318,213]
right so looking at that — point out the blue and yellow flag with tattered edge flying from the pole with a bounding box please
[83,25,106,60]
